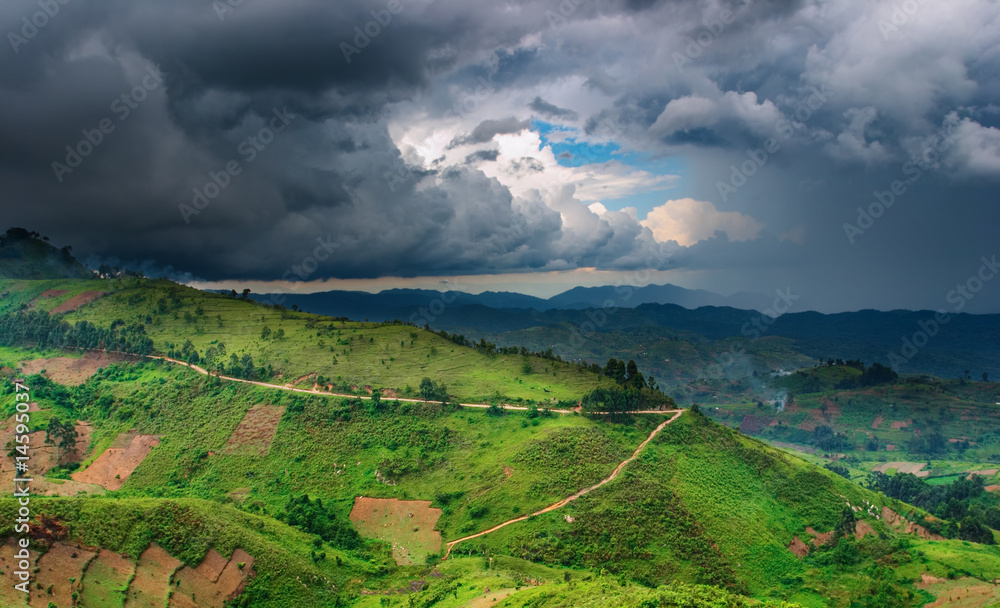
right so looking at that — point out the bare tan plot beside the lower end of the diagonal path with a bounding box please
[351,496,441,566]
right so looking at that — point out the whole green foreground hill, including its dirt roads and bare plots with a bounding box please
[0,239,1000,608]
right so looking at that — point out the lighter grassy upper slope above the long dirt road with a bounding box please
[0,279,613,404]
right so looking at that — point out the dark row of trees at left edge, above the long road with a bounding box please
[0,310,153,355]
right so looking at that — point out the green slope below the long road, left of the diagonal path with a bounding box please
[0,358,653,538]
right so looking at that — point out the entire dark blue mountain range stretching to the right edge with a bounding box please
[251,285,1000,382]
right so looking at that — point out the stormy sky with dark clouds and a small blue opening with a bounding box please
[0,0,1000,313]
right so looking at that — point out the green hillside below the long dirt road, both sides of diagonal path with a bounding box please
[0,349,1000,608]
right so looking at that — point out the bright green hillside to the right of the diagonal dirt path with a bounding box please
[456,413,916,595]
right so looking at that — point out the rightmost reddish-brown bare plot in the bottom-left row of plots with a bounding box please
[170,549,254,608]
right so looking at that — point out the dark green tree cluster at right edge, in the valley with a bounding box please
[865,472,1000,545]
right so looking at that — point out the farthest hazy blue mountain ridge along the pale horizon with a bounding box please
[251,284,773,325]
